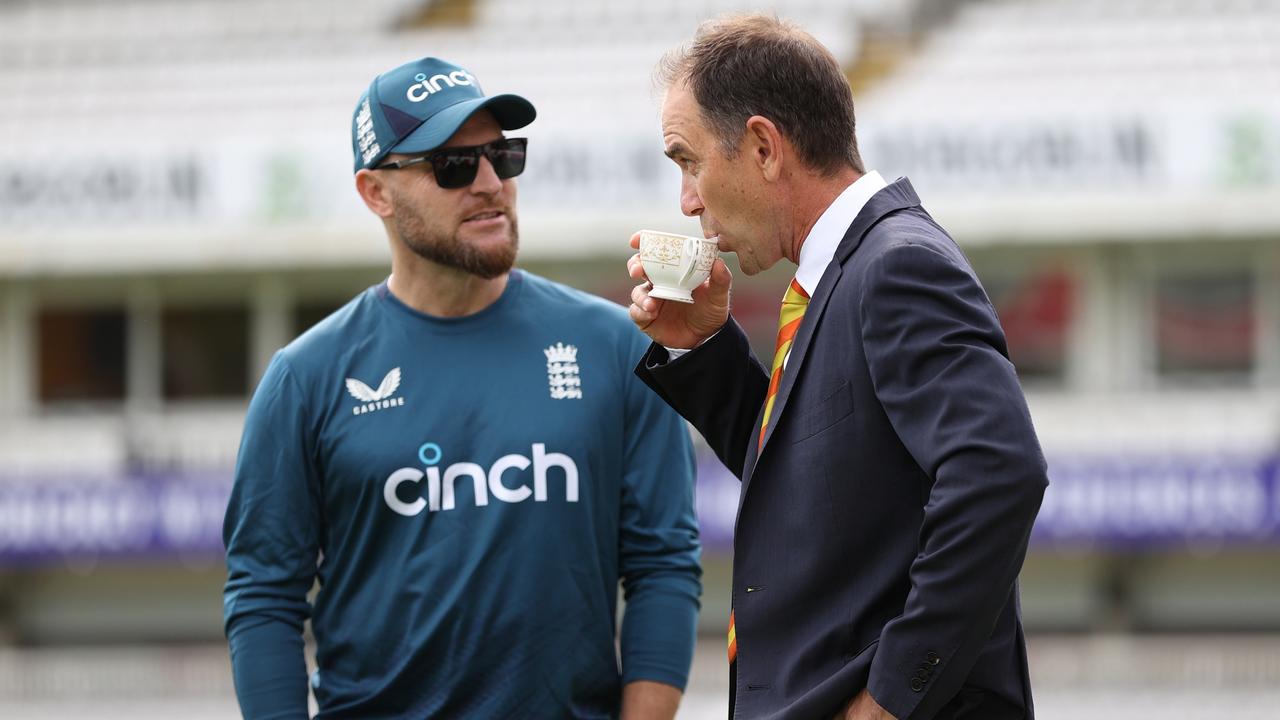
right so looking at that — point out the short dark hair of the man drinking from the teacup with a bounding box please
[655,14,864,174]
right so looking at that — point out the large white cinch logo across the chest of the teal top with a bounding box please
[383,442,577,518]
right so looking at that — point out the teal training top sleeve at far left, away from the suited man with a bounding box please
[223,354,320,720]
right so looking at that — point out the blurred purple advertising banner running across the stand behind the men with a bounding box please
[0,452,1280,564]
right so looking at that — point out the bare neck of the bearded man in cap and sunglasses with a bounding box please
[387,256,511,318]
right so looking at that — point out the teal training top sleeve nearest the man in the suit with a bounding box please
[618,332,701,689]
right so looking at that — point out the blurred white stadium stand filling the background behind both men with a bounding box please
[0,0,1280,719]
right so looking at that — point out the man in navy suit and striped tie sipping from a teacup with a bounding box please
[628,15,1047,720]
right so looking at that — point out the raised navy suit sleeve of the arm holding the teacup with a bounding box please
[636,318,769,479]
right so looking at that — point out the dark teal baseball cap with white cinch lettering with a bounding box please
[351,58,538,172]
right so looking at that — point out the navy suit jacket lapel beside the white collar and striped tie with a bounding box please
[742,178,920,479]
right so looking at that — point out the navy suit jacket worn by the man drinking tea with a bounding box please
[636,179,1048,720]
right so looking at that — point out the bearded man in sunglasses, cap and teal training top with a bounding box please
[224,58,701,720]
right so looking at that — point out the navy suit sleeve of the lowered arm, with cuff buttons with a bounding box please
[860,243,1048,720]
